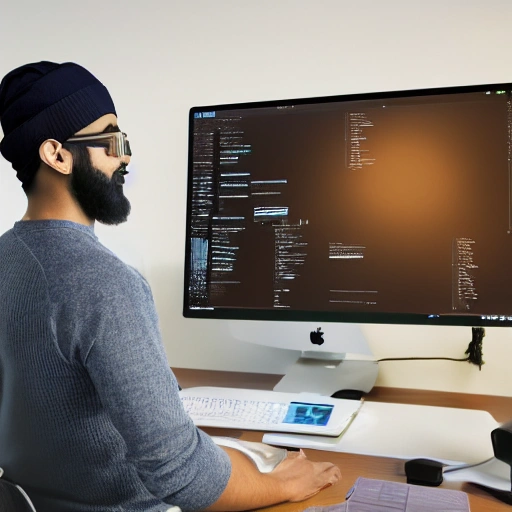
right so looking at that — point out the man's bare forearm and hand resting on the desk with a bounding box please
[206,448,341,512]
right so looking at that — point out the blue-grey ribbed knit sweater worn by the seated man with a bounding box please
[0,220,231,512]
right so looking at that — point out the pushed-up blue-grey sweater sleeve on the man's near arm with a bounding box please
[80,262,229,510]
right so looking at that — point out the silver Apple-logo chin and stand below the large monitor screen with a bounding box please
[228,320,378,399]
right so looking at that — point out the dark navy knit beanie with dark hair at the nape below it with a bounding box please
[0,61,116,185]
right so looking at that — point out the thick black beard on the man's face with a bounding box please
[67,145,130,225]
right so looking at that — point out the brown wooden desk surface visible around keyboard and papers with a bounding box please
[173,368,512,512]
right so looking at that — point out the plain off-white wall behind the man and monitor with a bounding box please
[0,0,512,396]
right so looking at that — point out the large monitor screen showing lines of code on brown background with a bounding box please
[184,84,512,326]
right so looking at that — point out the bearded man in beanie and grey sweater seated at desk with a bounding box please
[0,62,340,512]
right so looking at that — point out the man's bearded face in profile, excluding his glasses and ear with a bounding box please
[67,114,130,224]
